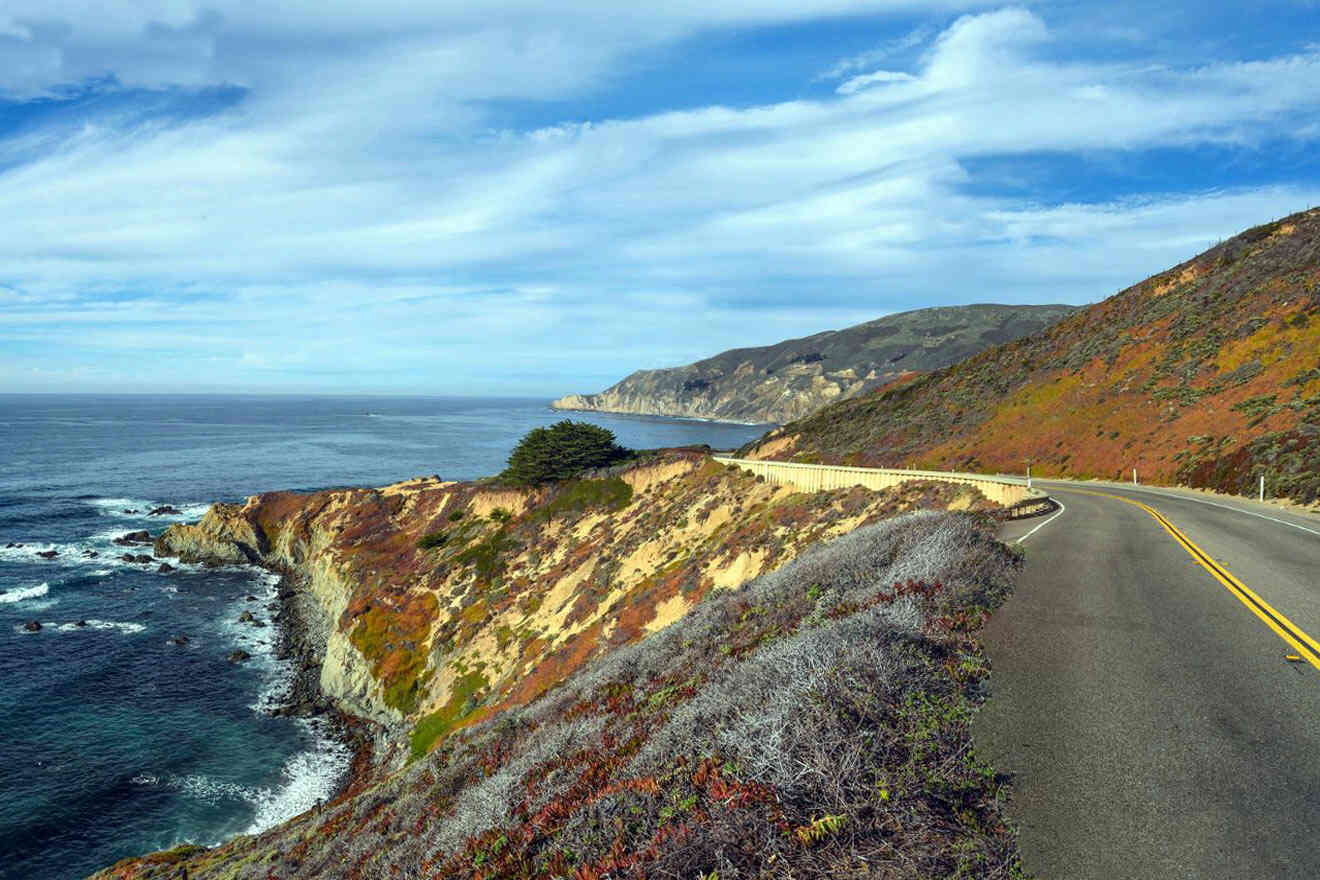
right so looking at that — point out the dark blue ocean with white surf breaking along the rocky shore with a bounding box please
[0,394,763,880]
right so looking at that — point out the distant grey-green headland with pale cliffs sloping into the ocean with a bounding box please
[552,305,1074,424]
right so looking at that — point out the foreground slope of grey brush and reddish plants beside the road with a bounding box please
[98,511,1023,880]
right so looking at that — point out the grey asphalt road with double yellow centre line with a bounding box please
[974,482,1320,880]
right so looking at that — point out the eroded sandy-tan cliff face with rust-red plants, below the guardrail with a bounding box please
[156,455,992,753]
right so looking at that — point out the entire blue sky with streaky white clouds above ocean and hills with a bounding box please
[0,0,1320,397]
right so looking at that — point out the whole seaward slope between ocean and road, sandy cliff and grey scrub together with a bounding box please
[98,451,1016,880]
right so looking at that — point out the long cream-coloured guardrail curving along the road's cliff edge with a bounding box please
[714,455,1053,519]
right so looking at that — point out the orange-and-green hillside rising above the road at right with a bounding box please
[746,210,1320,503]
